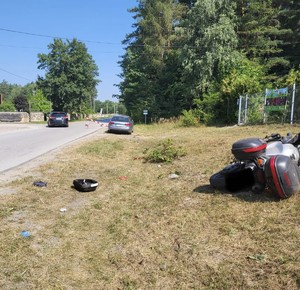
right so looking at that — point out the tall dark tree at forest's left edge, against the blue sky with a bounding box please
[120,0,185,118]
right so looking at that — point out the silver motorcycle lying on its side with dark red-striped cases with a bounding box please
[210,133,300,198]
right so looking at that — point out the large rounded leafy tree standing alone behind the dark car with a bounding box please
[37,39,99,113]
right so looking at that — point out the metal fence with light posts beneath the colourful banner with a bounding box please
[238,84,300,125]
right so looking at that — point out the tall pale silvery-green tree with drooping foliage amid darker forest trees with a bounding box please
[182,0,239,100]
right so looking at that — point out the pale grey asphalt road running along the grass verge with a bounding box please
[0,122,106,173]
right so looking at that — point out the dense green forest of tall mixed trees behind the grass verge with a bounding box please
[119,0,300,124]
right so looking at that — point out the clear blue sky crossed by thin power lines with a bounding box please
[0,0,137,101]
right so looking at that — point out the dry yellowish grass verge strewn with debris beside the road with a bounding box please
[0,124,300,290]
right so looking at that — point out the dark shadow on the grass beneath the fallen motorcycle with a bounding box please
[193,184,280,202]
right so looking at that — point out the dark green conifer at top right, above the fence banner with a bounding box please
[237,0,290,83]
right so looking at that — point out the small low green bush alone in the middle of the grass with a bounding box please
[144,139,186,163]
